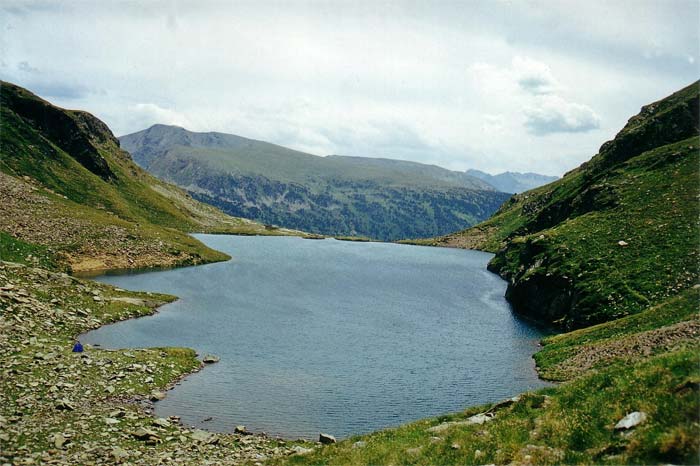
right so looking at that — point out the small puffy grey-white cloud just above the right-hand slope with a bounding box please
[524,95,600,136]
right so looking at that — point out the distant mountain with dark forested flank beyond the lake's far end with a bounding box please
[120,125,508,240]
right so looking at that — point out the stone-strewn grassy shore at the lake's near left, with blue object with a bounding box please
[0,262,315,465]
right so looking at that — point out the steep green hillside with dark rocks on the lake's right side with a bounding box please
[432,83,700,329]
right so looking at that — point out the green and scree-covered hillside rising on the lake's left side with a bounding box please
[0,82,298,270]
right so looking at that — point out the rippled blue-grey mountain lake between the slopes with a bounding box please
[84,235,544,438]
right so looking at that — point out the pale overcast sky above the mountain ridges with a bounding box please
[0,0,700,175]
